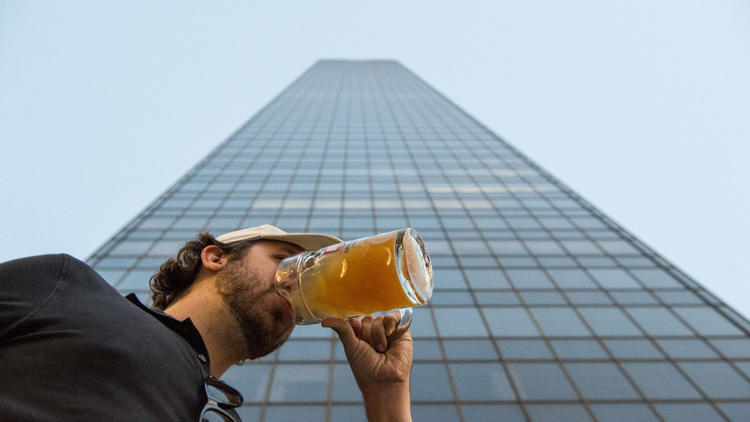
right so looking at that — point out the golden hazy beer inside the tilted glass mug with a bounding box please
[300,232,424,318]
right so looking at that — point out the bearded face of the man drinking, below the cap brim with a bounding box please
[216,240,302,359]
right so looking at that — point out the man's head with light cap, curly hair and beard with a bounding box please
[151,225,341,358]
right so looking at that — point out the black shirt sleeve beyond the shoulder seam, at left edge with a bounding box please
[0,254,70,343]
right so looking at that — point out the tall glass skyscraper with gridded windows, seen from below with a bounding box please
[88,61,750,422]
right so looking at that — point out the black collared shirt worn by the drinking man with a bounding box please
[0,255,214,422]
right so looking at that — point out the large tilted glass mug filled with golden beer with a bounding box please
[276,228,432,325]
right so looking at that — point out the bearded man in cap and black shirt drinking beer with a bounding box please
[0,225,412,421]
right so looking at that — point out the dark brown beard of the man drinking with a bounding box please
[216,260,293,359]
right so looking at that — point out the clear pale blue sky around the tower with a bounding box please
[0,0,750,316]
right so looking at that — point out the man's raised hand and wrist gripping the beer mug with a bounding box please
[321,313,413,421]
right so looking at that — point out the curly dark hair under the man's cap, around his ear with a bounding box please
[149,233,255,309]
